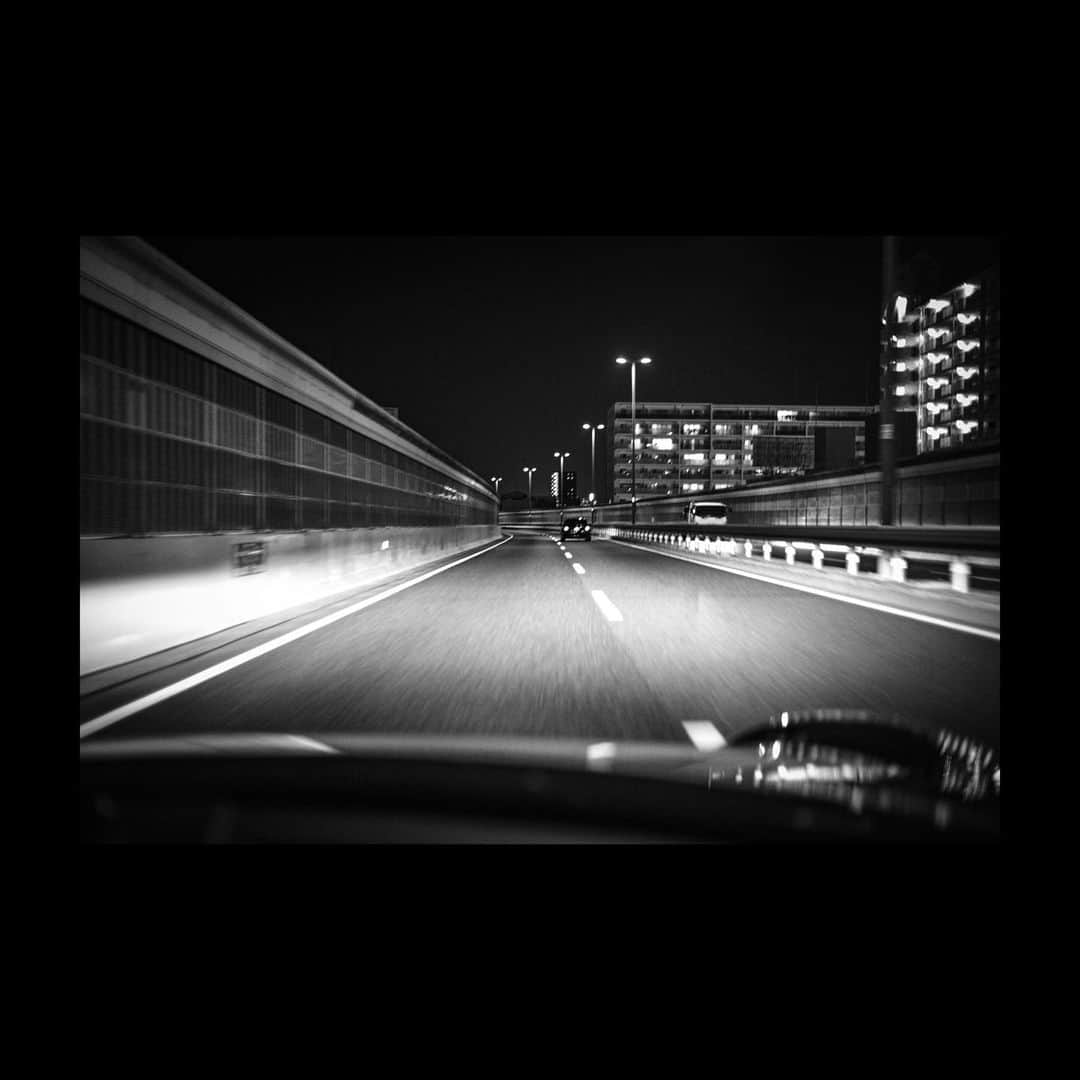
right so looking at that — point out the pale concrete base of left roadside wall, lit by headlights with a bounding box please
[79,525,500,675]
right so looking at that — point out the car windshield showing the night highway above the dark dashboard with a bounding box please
[79,235,1000,842]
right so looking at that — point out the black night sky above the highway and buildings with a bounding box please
[144,235,999,494]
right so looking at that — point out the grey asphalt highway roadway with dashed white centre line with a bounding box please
[81,536,1000,743]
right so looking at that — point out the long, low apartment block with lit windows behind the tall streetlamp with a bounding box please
[606,402,874,502]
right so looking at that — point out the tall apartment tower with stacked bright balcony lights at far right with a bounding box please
[880,268,1001,455]
